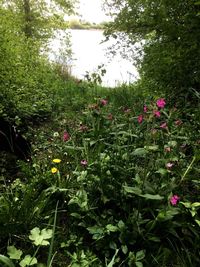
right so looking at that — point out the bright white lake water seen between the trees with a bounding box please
[50,30,139,87]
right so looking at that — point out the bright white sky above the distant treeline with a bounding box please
[78,0,110,23]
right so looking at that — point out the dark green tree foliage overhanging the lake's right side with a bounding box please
[105,0,200,95]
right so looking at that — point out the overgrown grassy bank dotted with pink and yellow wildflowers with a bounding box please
[0,76,200,267]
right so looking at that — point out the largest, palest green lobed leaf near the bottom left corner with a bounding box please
[29,227,53,246]
